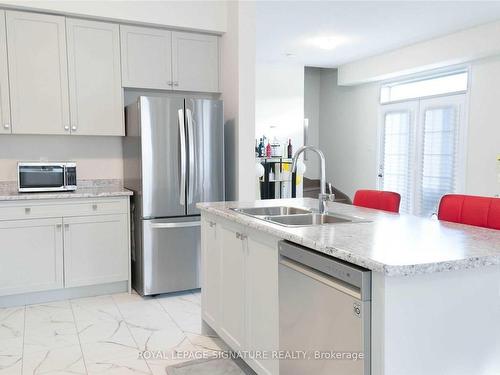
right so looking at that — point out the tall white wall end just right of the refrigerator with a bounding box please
[221,2,256,201]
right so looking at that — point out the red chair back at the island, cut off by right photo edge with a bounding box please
[438,194,500,229]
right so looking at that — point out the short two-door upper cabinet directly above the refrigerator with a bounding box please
[120,26,219,92]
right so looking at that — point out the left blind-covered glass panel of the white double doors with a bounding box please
[380,109,414,212]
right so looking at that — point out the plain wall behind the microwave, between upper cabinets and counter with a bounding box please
[0,135,123,181]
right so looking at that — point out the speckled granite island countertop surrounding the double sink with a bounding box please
[198,198,500,276]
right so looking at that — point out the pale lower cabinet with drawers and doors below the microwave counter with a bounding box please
[0,197,130,297]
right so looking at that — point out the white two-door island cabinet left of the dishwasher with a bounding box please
[202,218,279,374]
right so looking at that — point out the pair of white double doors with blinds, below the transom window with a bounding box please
[379,72,467,216]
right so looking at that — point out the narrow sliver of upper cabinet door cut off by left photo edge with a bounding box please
[0,10,11,134]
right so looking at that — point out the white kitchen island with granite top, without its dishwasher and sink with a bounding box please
[198,199,500,375]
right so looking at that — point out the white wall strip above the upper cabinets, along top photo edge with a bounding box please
[0,0,227,33]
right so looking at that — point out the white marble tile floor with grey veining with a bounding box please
[0,292,233,375]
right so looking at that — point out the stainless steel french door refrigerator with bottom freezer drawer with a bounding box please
[123,96,224,295]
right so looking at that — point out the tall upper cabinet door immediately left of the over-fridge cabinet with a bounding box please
[66,18,125,135]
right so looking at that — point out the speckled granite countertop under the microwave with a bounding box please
[0,180,133,201]
